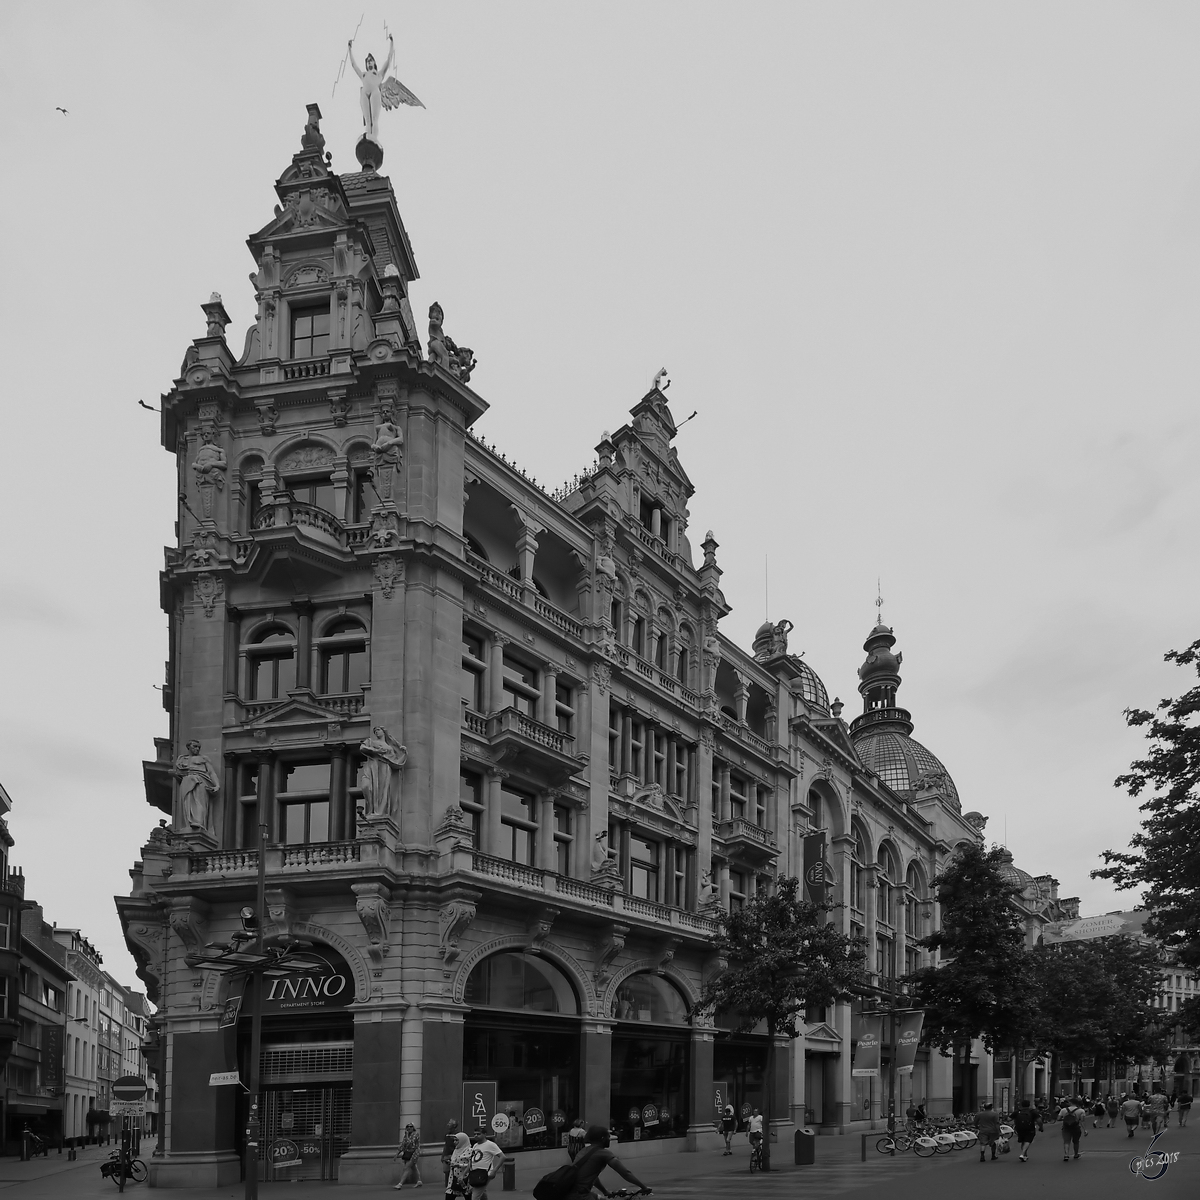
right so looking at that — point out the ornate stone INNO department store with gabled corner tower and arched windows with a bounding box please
[118,106,1046,1186]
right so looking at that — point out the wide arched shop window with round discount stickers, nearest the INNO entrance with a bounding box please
[462,953,582,1153]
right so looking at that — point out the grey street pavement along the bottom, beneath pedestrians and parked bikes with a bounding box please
[0,1126,1200,1200]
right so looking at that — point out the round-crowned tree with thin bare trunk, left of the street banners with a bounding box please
[694,876,865,1171]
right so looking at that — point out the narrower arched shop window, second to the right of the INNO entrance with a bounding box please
[608,973,691,1141]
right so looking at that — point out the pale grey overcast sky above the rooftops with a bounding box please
[0,0,1200,983]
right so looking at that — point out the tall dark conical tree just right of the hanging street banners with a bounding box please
[910,842,1037,1111]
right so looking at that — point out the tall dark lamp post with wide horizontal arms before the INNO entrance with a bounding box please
[184,822,324,1200]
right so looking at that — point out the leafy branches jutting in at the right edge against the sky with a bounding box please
[1092,642,1200,970]
